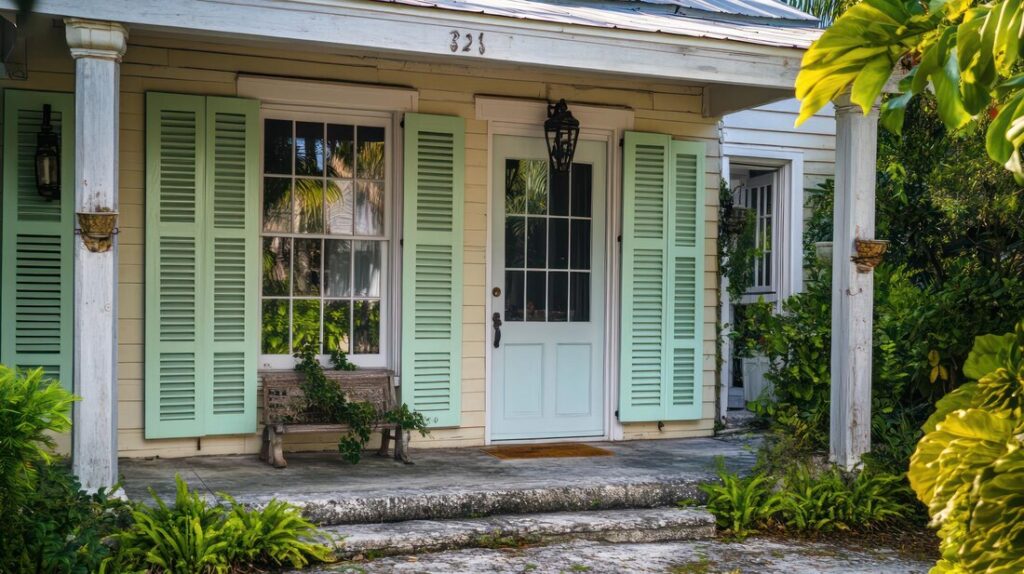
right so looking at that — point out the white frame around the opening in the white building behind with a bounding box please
[718,143,804,417]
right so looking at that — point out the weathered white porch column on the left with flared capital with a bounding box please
[65,18,128,491]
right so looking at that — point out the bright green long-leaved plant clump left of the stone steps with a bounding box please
[102,476,333,574]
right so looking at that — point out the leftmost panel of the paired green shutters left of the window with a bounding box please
[145,93,209,439]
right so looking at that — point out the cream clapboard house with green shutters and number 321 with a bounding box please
[0,0,874,487]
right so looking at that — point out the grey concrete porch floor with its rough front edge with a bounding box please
[120,435,759,524]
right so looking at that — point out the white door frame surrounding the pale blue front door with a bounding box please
[476,96,634,444]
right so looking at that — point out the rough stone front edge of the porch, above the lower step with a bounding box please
[280,479,717,526]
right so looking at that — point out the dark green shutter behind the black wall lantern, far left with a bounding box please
[0,90,75,390]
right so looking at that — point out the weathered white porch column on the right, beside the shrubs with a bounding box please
[828,93,879,470]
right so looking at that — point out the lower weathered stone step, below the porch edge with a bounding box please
[327,507,715,558]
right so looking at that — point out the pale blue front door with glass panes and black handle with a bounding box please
[487,136,607,440]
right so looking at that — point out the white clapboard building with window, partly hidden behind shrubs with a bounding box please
[719,99,836,416]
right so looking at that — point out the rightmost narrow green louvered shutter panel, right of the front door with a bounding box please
[665,141,705,421]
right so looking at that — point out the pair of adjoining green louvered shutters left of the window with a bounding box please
[145,93,259,438]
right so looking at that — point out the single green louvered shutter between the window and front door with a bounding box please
[401,114,465,427]
